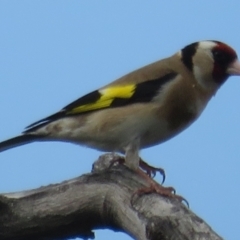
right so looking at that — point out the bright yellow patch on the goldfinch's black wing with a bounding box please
[68,84,136,114]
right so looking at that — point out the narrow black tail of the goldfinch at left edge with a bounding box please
[0,134,42,152]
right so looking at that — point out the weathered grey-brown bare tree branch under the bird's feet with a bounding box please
[0,154,222,240]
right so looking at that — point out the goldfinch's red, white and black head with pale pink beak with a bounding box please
[181,41,240,91]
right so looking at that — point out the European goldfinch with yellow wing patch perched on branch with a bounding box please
[0,41,240,174]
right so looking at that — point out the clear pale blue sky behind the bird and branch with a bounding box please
[0,0,240,240]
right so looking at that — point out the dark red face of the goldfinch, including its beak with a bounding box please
[212,41,240,84]
